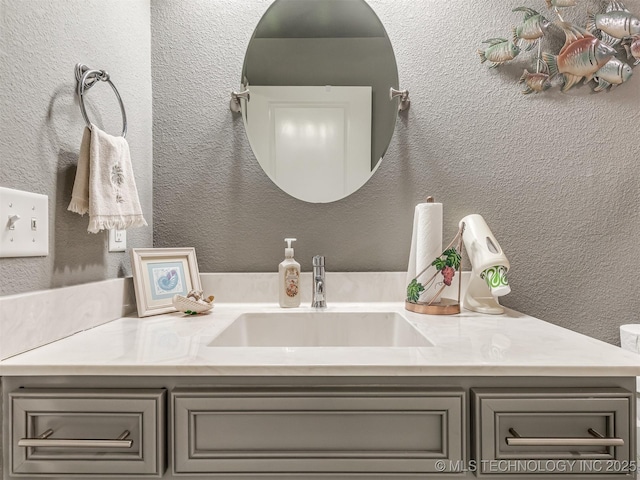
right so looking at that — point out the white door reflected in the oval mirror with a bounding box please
[243,85,371,203]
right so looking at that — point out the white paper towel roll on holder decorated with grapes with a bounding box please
[407,202,442,300]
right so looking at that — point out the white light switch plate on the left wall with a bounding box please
[0,187,49,257]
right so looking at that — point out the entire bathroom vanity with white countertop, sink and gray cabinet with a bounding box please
[0,302,640,479]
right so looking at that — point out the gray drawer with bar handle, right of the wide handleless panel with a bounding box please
[471,388,636,478]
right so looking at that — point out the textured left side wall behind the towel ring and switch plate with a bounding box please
[0,0,153,294]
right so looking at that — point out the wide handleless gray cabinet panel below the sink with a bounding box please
[170,387,465,475]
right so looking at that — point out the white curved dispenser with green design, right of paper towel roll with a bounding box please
[460,214,511,314]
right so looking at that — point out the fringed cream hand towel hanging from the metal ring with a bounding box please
[69,125,147,233]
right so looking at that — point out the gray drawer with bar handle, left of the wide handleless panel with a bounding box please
[9,389,166,477]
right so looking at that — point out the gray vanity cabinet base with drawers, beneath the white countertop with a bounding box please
[0,375,638,480]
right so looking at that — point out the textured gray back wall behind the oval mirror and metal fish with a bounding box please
[151,0,640,343]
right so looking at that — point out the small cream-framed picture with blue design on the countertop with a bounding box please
[131,248,202,317]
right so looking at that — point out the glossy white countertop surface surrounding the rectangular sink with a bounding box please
[0,302,640,377]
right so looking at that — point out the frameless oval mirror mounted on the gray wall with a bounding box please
[241,0,398,203]
